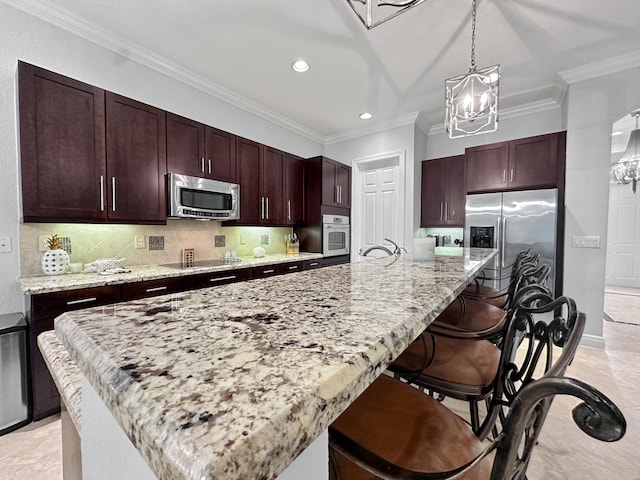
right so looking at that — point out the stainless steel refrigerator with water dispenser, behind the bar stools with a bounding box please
[464,188,564,296]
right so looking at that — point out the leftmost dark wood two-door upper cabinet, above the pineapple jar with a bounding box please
[18,62,166,224]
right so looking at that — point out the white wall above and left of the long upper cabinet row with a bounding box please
[0,3,322,314]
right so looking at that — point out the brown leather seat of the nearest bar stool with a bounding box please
[329,375,491,480]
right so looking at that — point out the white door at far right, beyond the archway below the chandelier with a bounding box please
[605,185,640,288]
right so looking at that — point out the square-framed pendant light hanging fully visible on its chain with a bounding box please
[444,0,500,138]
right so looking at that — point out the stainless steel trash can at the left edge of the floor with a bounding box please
[0,313,31,435]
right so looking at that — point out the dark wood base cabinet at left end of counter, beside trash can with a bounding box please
[28,286,120,420]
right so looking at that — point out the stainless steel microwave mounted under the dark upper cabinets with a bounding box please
[167,173,240,220]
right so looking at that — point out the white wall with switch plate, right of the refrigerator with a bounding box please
[564,68,640,345]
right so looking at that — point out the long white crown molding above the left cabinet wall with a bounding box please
[0,0,325,144]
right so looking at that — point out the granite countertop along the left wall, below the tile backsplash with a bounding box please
[20,253,322,295]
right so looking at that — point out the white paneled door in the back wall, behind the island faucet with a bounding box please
[352,154,404,260]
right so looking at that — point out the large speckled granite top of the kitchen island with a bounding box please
[56,249,495,480]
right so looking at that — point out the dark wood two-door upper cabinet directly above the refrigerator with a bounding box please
[466,132,566,192]
